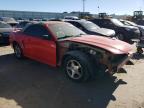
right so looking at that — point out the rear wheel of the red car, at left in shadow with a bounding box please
[13,44,23,59]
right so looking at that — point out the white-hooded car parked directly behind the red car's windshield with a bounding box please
[65,20,115,37]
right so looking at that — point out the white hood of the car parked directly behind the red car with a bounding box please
[91,28,115,37]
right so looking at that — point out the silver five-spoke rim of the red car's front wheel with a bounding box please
[66,60,83,80]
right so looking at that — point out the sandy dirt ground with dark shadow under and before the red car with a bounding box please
[0,46,144,108]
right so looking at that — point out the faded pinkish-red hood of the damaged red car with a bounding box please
[65,35,133,54]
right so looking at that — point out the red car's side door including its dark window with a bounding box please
[23,24,56,66]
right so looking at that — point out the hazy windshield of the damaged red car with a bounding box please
[49,23,85,39]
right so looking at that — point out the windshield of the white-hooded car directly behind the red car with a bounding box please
[80,21,100,30]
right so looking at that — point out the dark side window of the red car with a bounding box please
[24,24,50,38]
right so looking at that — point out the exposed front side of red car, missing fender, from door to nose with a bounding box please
[60,41,133,74]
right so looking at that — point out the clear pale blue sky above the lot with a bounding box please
[0,0,144,15]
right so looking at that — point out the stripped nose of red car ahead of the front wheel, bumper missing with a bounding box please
[85,48,133,75]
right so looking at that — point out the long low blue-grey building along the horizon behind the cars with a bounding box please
[0,10,127,19]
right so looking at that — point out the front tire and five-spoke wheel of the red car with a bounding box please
[63,51,93,82]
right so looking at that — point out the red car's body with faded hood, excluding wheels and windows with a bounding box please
[10,21,132,78]
